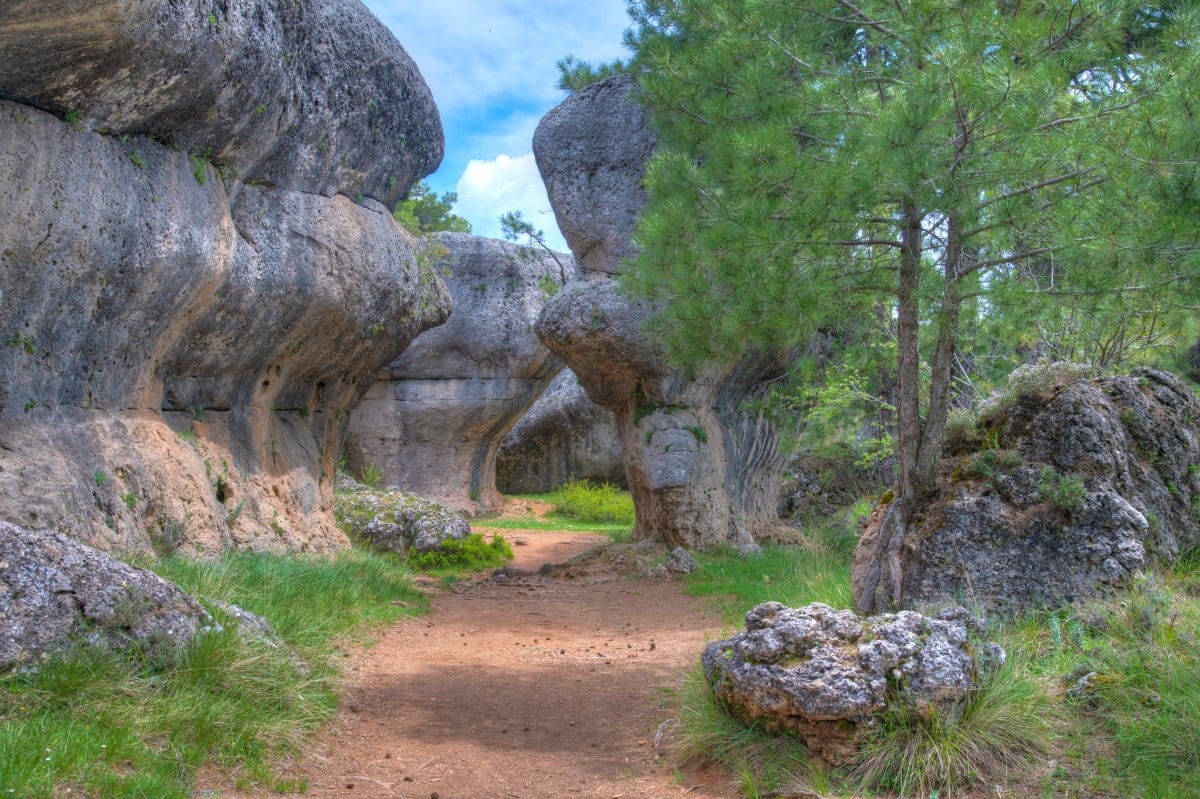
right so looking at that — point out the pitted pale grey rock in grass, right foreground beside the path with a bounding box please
[702,602,1004,765]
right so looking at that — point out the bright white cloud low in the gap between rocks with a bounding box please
[455,152,566,252]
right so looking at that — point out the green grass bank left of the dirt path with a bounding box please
[0,552,425,799]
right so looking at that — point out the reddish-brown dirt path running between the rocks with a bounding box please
[210,530,736,799]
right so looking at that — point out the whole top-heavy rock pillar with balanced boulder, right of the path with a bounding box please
[534,76,786,548]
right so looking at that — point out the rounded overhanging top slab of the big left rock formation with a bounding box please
[0,0,443,205]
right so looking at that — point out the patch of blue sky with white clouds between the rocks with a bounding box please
[364,0,629,251]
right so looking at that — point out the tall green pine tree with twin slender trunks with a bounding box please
[625,0,1194,604]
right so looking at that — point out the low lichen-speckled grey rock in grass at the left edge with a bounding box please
[0,522,212,671]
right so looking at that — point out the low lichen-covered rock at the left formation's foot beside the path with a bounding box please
[335,479,470,555]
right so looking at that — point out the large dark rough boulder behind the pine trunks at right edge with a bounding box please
[853,370,1200,613]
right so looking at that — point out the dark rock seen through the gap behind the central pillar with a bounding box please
[496,370,628,494]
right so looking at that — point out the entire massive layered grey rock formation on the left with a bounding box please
[0,0,449,552]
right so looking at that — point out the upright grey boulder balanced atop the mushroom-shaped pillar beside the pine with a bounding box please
[533,76,658,275]
